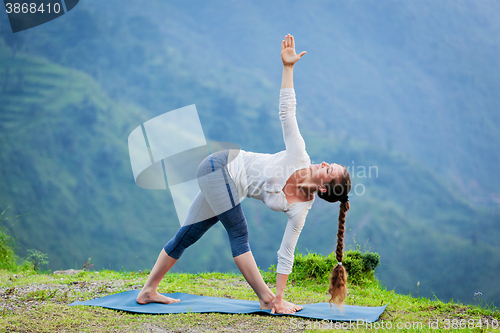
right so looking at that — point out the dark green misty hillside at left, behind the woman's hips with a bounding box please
[0,47,240,269]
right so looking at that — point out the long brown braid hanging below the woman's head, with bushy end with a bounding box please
[328,200,350,309]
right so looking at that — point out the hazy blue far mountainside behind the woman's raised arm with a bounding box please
[5,0,500,202]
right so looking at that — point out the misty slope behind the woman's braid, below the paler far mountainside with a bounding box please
[298,133,500,302]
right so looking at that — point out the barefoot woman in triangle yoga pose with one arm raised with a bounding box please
[137,34,351,313]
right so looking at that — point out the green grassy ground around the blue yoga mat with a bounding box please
[0,270,500,332]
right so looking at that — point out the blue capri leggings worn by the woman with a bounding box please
[164,150,250,259]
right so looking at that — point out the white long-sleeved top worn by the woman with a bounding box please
[227,88,314,275]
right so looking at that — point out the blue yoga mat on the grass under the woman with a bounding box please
[70,290,388,323]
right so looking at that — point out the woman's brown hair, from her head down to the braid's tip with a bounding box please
[318,167,351,309]
